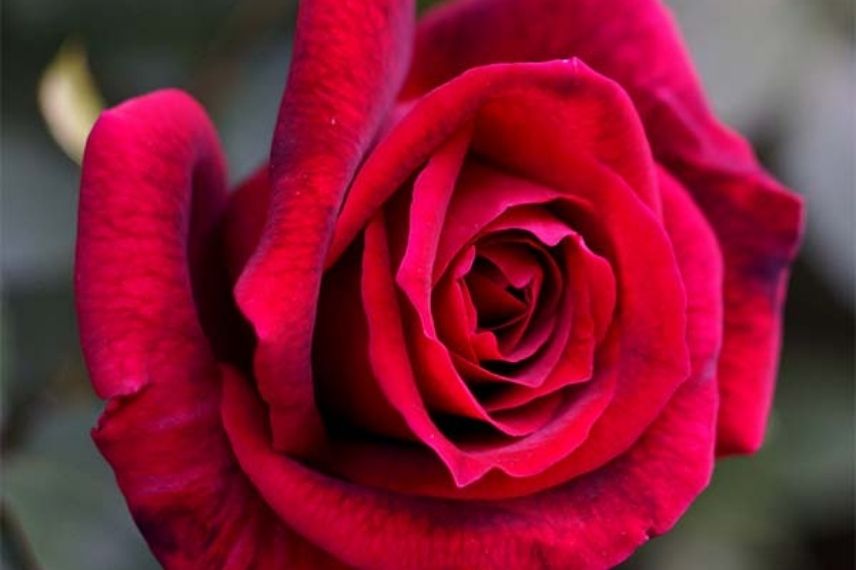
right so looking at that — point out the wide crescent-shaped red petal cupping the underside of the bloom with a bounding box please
[222,358,716,570]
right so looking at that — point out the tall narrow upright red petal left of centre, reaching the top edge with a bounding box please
[236,0,414,453]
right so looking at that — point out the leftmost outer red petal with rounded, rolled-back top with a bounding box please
[75,91,336,570]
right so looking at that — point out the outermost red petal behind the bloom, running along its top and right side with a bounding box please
[402,0,802,453]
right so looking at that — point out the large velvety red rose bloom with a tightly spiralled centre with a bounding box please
[76,0,802,569]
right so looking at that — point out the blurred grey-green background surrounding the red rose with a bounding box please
[0,0,856,570]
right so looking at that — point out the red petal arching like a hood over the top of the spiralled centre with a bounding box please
[327,60,659,266]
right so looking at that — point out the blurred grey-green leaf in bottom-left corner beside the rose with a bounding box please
[2,397,157,570]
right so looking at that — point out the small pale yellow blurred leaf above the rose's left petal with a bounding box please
[39,40,104,164]
